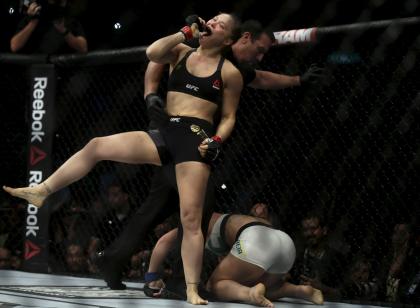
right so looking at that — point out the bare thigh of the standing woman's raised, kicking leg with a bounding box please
[91,131,160,165]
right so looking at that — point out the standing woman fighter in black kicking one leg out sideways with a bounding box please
[3,13,243,304]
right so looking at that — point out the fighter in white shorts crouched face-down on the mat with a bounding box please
[145,213,323,307]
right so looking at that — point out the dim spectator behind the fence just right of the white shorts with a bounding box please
[291,211,345,300]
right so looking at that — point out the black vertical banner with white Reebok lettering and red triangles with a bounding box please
[23,65,55,272]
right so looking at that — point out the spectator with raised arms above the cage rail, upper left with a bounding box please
[10,0,88,54]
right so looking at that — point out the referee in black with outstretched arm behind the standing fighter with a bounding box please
[93,15,321,289]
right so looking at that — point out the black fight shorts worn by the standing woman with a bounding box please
[147,117,215,165]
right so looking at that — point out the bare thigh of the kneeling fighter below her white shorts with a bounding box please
[209,253,265,285]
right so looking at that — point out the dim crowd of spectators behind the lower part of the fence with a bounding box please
[0,178,420,303]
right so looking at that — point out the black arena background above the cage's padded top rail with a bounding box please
[0,0,419,52]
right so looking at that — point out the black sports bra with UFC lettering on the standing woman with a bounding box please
[168,49,225,106]
